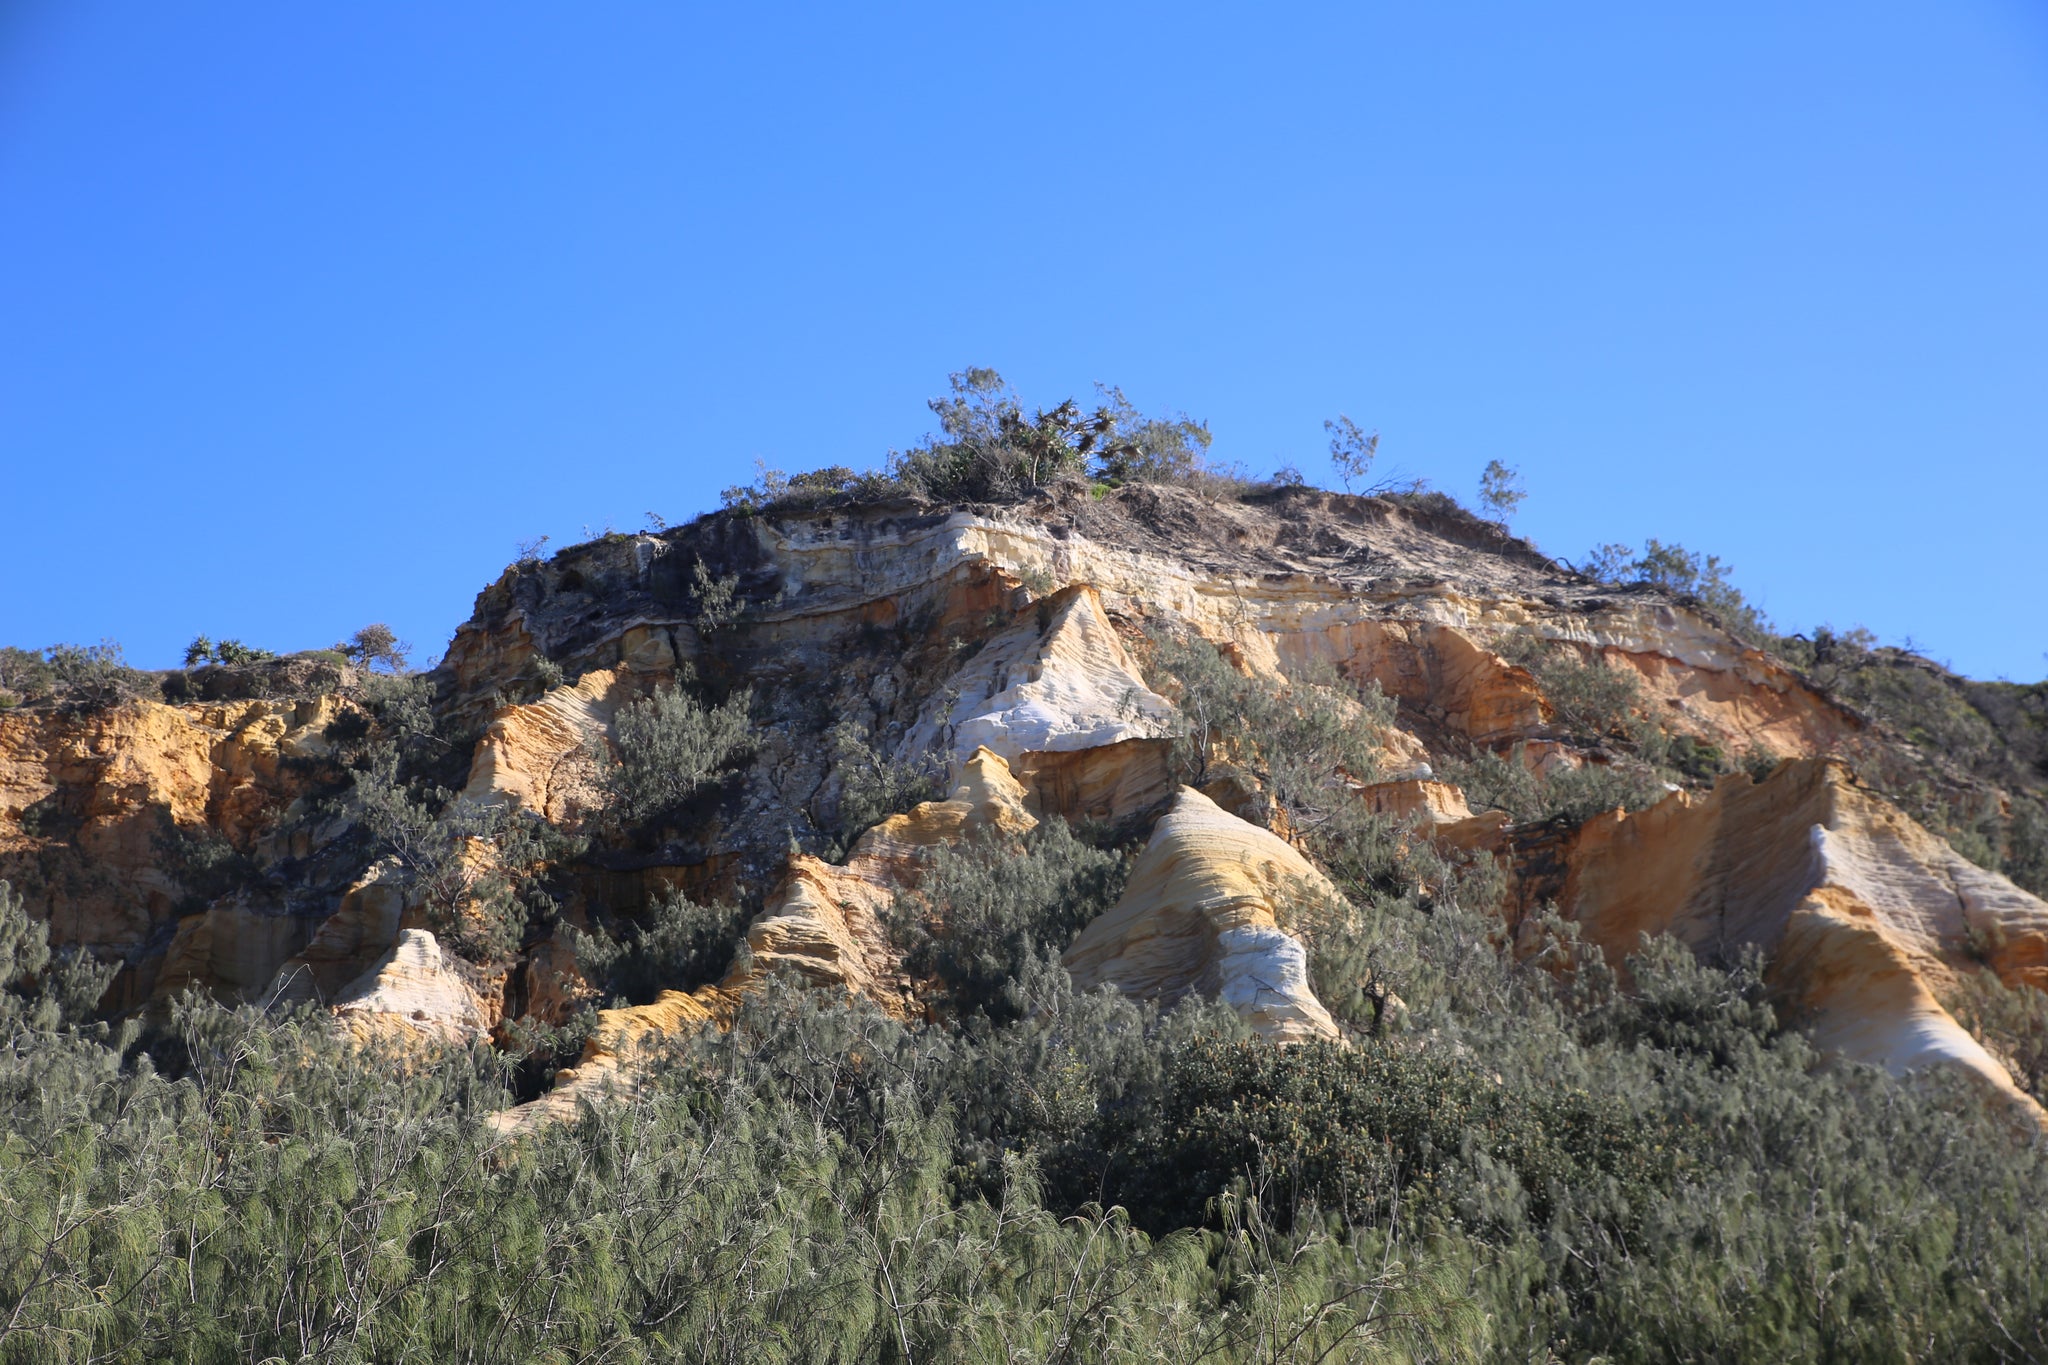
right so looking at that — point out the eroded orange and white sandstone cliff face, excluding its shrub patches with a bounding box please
[0,485,2048,1124]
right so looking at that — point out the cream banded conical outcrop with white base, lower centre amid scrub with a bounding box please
[1061,788,1337,1042]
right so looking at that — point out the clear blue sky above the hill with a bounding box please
[0,0,2048,679]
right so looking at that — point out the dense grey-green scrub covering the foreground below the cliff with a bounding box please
[0,835,2048,1361]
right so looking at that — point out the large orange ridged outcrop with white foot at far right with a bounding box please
[1524,759,2048,1119]
